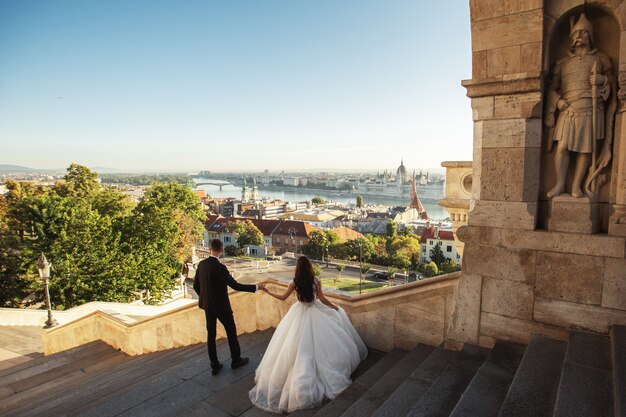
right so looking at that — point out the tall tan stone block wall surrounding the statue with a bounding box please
[447,0,626,346]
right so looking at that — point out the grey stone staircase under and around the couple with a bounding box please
[0,326,626,417]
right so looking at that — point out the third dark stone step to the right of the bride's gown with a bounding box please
[374,347,457,417]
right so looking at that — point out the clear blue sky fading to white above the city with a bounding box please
[0,0,472,171]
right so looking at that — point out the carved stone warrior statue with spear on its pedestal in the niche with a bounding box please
[542,9,619,233]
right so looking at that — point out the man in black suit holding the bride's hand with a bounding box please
[193,239,265,375]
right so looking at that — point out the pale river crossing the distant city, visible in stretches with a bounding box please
[196,178,448,220]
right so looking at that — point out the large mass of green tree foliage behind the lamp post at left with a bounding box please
[0,164,204,308]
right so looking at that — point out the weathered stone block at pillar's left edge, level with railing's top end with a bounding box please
[463,243,535,284]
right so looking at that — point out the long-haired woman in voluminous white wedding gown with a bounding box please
[249,256,367,413]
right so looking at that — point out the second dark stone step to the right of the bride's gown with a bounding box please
[342,344,435,417]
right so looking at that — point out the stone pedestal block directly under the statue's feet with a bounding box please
[547,195,602,233]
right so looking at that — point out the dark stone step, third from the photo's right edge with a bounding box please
[499,336,567,417]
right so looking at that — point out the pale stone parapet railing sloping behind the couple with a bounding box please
[43,273,460,355]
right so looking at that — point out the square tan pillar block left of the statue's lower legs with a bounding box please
[480,147,540,201]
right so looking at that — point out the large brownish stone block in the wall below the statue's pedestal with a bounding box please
[535,252,604,305]
